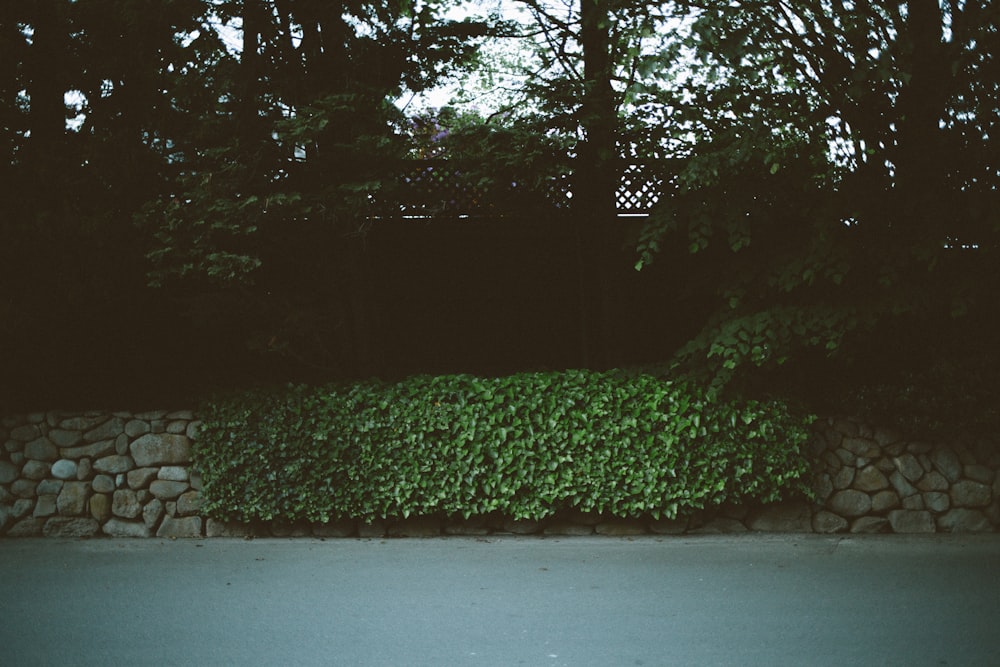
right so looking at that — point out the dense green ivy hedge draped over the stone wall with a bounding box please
[195,371,808,522]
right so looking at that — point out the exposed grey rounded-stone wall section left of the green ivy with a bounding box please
[0,410,202,537]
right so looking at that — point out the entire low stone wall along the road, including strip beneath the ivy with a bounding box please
[0,410,1000,537]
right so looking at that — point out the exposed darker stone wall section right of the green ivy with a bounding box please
[813,419,1000,533]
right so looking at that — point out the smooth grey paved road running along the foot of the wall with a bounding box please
[0,535,1000,667]
